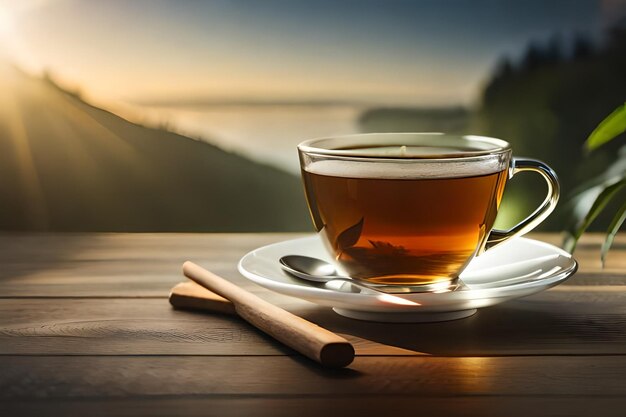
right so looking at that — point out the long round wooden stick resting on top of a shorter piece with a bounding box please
[183,261,354,368]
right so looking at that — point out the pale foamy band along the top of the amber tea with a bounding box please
[305,146,507,179]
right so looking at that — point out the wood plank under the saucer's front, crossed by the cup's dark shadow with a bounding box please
[0,290,626,356]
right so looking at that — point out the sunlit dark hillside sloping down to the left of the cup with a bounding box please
[0,66,311,232]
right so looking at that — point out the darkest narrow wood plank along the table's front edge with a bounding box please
[0,395,626,417]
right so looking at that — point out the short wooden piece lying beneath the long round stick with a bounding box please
[170,281,237,315]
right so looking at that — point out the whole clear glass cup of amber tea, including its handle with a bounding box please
[298,133,559,292]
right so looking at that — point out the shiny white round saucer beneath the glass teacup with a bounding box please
[238,235,578,322]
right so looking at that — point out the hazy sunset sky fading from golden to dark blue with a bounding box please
[0,0,625,106]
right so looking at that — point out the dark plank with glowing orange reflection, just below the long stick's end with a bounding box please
[0,356,626,401]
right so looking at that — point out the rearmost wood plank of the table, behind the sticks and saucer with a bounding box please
[0,233,626,298]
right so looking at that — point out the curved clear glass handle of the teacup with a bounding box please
[485,158,561,250]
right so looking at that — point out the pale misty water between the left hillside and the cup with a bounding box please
[133,104,367,175]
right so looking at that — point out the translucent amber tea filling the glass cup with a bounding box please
[303,154,507,285]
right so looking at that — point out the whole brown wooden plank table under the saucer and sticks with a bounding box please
[0,234,626,416]
